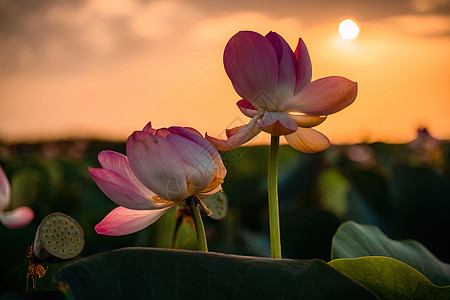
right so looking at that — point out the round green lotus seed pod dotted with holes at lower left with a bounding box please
[34,213,84,262]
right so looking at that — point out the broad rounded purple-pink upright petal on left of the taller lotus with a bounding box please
[223,31,278,108]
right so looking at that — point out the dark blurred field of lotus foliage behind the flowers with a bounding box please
[0,129,450,294]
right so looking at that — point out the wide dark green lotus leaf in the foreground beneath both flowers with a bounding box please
[54,248,375,300]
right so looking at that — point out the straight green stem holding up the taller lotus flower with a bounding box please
[268,136,281,258]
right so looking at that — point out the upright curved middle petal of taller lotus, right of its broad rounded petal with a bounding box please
[266,31,297,105]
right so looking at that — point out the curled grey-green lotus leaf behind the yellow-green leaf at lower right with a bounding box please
[331,221,450,286]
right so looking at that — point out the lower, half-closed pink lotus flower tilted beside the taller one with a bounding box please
[89,123,226,235]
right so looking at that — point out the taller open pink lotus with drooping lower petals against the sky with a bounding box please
[206,31,357,153]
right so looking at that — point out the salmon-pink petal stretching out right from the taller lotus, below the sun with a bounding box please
[282,76,358,116]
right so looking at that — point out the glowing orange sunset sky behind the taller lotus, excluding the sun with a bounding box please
[0,0,450,143]
